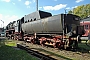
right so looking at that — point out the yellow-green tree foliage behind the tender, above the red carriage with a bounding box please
[68,4,90,19]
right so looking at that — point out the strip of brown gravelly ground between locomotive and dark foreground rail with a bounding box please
[17,41,90,60]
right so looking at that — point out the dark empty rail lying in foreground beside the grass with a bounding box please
[17,44,57,60]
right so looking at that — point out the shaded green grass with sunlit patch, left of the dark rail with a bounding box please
[0,40,38,60]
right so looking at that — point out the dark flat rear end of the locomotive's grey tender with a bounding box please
[64,14,84,36]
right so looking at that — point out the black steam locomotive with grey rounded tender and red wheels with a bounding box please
[6,10,84,49]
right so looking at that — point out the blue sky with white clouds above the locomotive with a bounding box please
[0,0,90,27]
